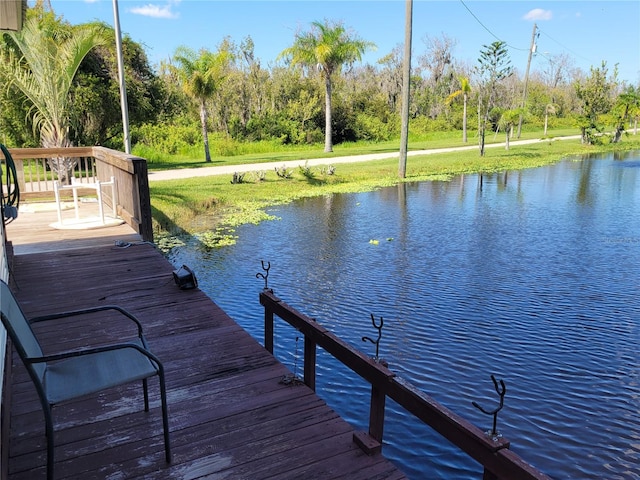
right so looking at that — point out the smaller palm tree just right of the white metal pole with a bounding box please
[173,45,233,162]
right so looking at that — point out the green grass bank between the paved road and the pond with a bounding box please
[150,137,640,246]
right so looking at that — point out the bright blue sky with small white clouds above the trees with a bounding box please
[51,0,640,85]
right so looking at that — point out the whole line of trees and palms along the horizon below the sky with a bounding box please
[0,1,640,161]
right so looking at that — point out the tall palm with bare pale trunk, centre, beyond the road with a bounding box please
[279,20,375,152]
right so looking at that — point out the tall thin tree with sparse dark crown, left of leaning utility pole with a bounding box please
[477,41,513,156]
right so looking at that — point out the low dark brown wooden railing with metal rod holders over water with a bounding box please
[260,289,550,480]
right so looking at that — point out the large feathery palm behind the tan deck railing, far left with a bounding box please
[0,8,107,181]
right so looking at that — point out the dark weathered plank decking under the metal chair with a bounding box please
[2,205,405,480]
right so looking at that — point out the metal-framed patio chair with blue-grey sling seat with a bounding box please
[0,280,171,480]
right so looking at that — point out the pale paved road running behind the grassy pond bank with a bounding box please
[149,135,580,182]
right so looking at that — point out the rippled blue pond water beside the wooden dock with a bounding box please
[171,152,640,480]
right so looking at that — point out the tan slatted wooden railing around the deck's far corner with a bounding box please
[0,147,153,242]
